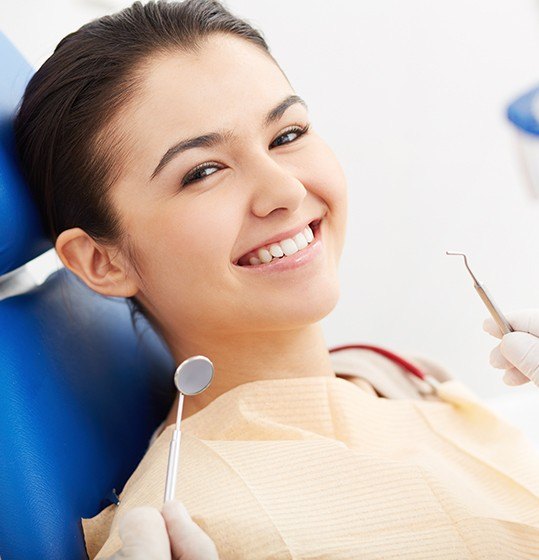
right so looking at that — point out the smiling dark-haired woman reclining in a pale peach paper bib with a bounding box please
[11,0,539,560]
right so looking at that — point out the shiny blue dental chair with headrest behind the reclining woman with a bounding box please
[0,33,175,560]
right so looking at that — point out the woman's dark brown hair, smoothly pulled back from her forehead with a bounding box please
[14,0,284,330]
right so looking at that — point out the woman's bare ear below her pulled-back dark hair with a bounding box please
[55,228,139,297]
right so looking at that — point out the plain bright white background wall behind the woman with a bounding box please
[4,0,539,412]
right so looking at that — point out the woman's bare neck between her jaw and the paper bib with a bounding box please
[165,323,335,426]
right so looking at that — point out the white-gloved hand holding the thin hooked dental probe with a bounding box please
[483,308,539,387]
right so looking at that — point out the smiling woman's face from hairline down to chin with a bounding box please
[110,34,347,344]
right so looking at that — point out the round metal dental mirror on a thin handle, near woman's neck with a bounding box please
[164,356,213,502]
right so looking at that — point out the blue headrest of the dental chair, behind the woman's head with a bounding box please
[0,33,52,276]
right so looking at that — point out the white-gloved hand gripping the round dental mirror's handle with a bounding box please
[102,500,219,560]
